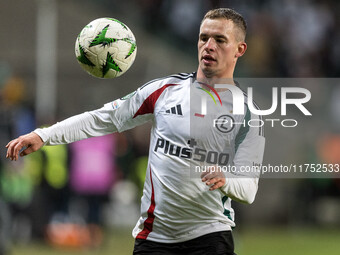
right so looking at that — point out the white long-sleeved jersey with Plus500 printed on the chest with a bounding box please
[35,73,264,243]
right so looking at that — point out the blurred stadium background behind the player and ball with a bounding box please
[0,0,340,255]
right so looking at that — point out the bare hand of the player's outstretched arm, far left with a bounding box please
[6,132,44,160]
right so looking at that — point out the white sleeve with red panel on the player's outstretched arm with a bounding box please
[34,79,164,145]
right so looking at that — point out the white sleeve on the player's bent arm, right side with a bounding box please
[221,110,265,204]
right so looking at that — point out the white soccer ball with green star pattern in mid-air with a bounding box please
[75,18,137,79]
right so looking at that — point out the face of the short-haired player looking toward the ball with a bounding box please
[197,19,247,78]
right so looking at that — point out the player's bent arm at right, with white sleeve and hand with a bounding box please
[201,112,265,204]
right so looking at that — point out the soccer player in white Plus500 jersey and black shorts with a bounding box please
[6,8,264,255]
